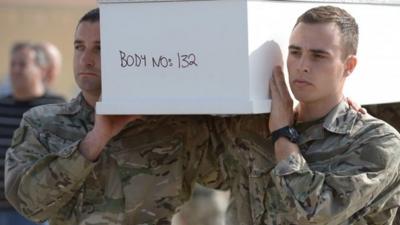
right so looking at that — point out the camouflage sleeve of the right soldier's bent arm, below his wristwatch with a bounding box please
[271,134,400,224]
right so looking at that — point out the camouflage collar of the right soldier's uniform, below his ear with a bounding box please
[323,100,357,134]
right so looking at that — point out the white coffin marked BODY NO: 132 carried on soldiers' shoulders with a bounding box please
[96,0,400,114]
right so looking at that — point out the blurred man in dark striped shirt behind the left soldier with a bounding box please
[0,42,65,225]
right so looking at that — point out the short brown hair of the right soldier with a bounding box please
[294,6,358,58]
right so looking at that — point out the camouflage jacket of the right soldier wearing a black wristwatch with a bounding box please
[219,102,400,225]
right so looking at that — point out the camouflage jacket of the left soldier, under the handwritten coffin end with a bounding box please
[5,95,228,225]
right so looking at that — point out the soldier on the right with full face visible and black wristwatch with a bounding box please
[222,6,400,225]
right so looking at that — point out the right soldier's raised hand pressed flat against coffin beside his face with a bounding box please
[269,66,293,132]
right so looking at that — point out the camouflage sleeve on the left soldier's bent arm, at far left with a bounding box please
[5,118,95,221]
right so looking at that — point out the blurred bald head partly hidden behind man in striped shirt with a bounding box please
[37,42,62,86]
